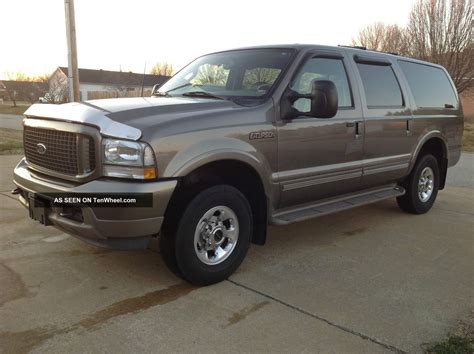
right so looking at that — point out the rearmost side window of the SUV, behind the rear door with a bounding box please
[398,60,458,108]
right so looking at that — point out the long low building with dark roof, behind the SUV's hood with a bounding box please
[49,66,169,101]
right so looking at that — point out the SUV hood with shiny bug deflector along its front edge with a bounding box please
[25,97,241,140]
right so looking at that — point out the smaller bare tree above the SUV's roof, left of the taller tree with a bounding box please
[352,22,408,54]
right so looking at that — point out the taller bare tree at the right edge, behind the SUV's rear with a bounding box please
[407,0,474,92]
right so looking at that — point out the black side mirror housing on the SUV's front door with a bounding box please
[310,80,338,118]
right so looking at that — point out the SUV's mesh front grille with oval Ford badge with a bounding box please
[23,126,95,176]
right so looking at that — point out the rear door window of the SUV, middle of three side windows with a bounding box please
[357,63,403,108]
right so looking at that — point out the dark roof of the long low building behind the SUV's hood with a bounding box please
[58,66,170,86]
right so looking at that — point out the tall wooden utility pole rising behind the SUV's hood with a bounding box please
[64,0,81,102]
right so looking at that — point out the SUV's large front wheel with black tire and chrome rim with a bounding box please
[160,185,252,285]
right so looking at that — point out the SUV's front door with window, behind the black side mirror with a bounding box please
[276,50,363,208]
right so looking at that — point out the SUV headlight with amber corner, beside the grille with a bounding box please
[102,139,156,179]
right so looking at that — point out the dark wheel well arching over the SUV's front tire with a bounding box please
[165,160,267,245]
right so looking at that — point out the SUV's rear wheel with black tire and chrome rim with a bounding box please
[397,154,440,214]
